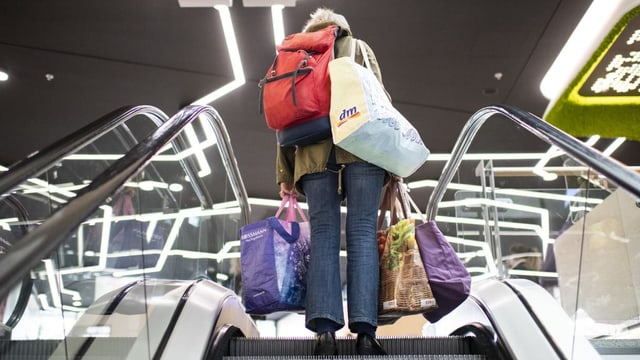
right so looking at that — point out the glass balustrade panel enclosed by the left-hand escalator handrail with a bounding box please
[0,112,243,356]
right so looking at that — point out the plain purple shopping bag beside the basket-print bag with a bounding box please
[406,194,471,323]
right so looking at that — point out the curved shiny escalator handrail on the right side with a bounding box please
[426,105,640,220]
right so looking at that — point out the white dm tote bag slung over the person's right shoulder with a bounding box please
[329,39,429,177]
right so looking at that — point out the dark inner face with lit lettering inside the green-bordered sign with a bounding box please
[578,15,640,97]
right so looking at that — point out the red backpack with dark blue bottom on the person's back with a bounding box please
[258,25,340,146]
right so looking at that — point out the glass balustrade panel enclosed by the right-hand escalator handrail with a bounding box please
[430,119,640,353]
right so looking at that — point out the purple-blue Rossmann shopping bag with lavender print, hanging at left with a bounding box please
[240,196,310,315]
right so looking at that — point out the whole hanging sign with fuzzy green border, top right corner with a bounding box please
[544,6,640,141]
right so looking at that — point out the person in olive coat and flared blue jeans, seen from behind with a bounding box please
[276,8,387,355]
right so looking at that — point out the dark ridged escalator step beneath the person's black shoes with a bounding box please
[229,336,480,357]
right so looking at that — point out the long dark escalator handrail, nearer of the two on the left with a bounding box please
[0,105,242,298]
